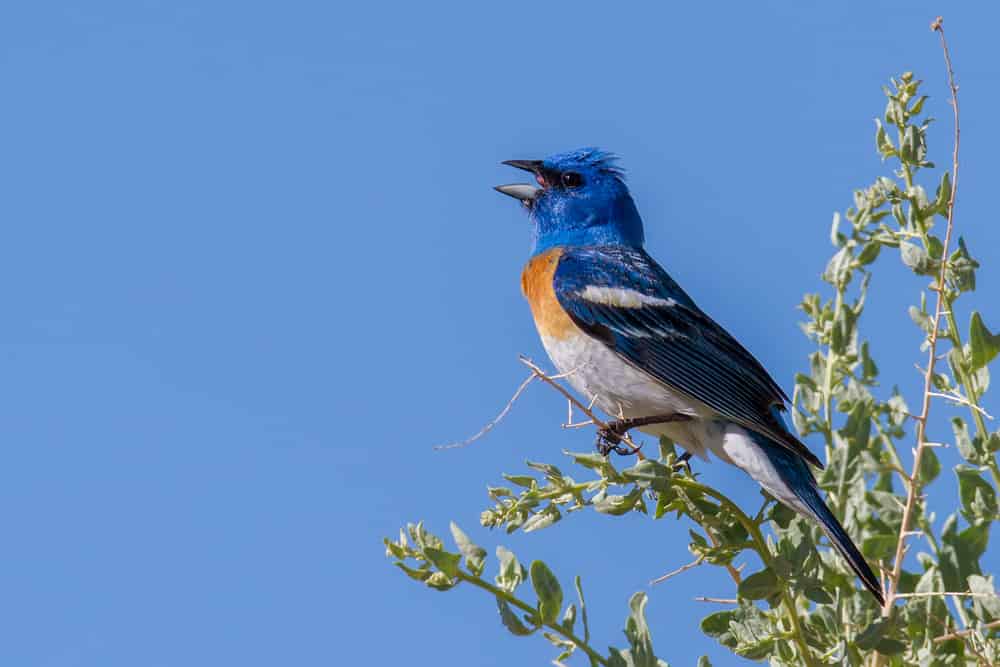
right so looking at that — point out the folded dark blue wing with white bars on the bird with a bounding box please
[553,246,823,468]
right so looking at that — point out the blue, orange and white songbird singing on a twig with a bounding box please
[495,148,885,606]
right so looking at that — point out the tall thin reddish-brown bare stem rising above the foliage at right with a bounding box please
[882,16,961,617]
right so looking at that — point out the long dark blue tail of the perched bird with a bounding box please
[755,437,885,606]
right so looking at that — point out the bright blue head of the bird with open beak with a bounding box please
[496,148,643,254]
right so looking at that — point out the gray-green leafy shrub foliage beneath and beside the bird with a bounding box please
[386,73,1000,666]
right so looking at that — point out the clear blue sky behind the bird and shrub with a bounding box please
[0,0,1000,667]
